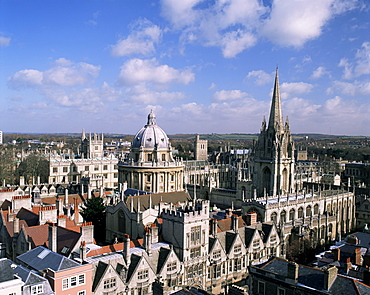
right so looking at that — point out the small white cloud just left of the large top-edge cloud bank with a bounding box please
[111,19,162,56]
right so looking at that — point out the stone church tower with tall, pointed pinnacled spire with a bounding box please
[250,69,294,196]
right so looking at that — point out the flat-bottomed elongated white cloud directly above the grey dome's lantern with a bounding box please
[117,58,194,85]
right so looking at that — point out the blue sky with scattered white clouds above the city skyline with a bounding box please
[0,0,370,136]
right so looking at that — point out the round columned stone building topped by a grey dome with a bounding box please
[118,111,184,193]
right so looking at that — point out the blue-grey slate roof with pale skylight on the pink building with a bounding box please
[17,246,80,271]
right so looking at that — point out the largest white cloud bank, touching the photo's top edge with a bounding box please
[161,0,360,58]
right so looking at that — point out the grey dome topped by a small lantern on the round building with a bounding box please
[131,110,171,150]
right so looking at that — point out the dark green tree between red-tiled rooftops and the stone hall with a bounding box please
[80,197,105,242]
